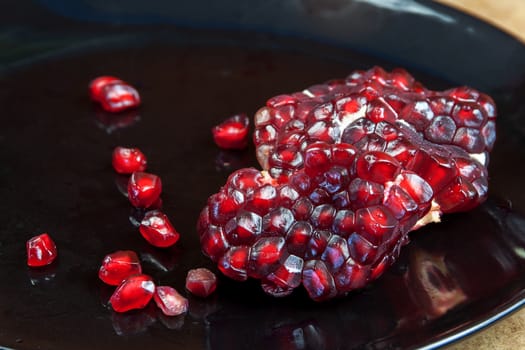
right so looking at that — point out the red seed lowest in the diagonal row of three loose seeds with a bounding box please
[139,210,180,248]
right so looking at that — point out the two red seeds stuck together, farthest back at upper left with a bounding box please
[89,76,140,113]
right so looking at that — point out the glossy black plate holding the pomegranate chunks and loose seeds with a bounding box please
[0,0,525,349]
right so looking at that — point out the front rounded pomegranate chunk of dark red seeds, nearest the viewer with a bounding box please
[198,142,424,301]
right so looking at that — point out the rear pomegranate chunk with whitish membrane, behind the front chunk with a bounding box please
[254,67,496,213]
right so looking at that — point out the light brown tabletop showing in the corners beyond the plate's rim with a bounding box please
[432,0,525,350]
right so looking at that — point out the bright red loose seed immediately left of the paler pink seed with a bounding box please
[109,274,155,312]
